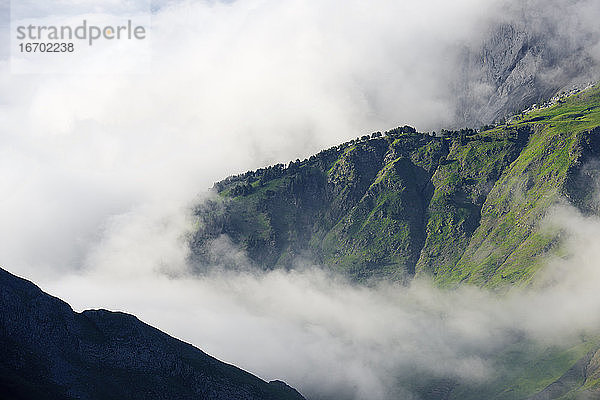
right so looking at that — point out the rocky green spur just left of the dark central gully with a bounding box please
[321,135,444,277]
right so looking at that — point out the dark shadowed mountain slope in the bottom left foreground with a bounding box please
[0,269,303,400]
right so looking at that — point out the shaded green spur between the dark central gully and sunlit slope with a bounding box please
[417,135,522,276]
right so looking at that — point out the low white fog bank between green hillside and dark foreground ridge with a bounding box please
[47,205,600,399]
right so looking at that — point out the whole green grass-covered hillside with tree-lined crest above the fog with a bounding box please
[192,87,600,286]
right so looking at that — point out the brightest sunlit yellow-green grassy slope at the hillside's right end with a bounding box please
[448,88,600,286]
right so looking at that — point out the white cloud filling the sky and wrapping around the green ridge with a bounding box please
[0,0,600,399]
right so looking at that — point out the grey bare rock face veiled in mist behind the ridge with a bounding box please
[456,20,600,126]
